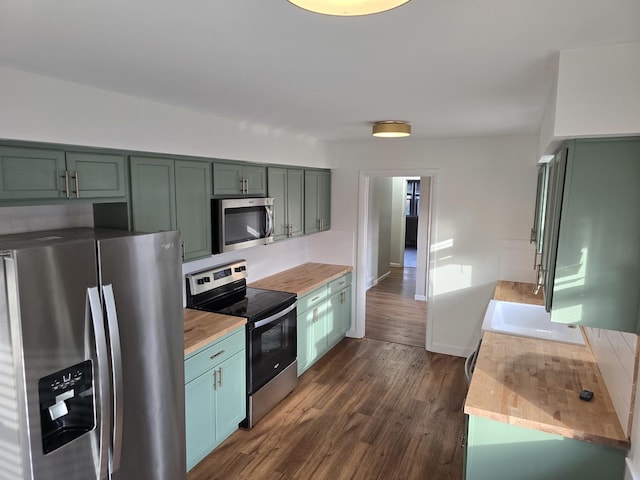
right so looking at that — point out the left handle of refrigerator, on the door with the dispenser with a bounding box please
[85,287,111,480]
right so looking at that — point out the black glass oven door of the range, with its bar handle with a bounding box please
[247,302,298,395]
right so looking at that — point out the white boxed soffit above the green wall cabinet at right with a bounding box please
[540,43,640,153]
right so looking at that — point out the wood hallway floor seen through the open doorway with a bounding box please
[364,267,427,348]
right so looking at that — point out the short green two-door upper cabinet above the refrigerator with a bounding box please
[0,146,127,200]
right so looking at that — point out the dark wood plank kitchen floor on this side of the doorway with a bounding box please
[188,338,466,480]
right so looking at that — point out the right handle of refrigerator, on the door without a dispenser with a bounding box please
[102,284,122,474]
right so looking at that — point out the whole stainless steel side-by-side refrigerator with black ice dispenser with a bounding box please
[0,228,186,480]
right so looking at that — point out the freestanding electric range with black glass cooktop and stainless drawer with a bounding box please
[186,260,298,428]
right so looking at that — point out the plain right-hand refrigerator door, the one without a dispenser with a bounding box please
[98,232,186,480]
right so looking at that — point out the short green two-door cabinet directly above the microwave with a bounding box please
[213,162,267,197]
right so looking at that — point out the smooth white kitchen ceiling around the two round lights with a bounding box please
[0,0,640,140]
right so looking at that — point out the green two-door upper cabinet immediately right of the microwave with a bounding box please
[267,167,304,240]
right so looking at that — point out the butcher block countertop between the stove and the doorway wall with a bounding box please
[249,263,352,297]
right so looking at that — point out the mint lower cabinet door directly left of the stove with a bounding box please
[215,350,247,444]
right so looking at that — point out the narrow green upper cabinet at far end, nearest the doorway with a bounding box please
[304,170,331,234]
